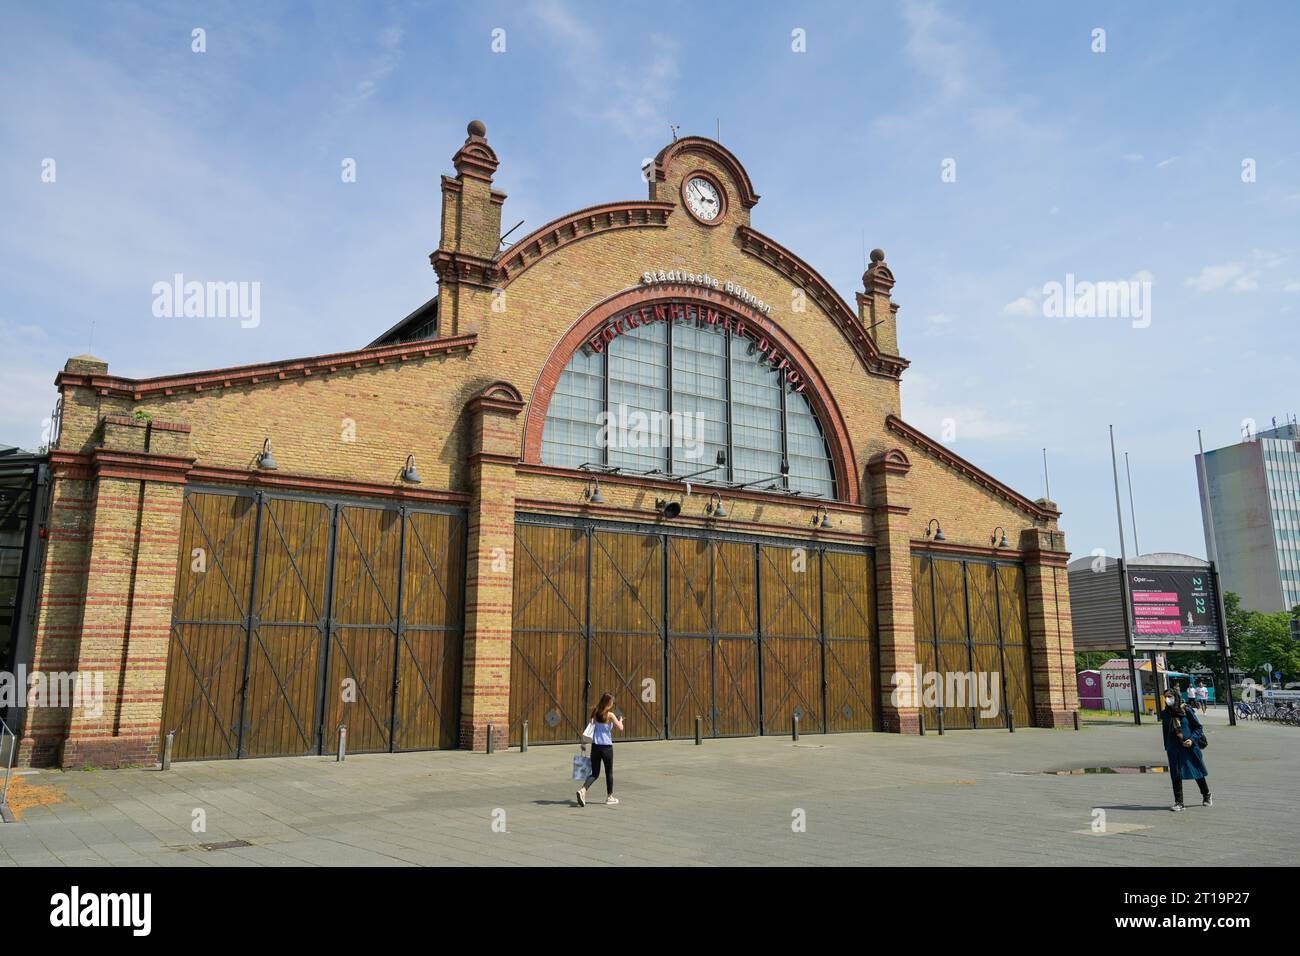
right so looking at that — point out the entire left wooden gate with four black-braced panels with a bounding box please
[163,489,465,760]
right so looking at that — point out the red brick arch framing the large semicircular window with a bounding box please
[523,284,861,503]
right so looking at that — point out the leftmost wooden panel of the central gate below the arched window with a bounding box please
[510,524,587,743]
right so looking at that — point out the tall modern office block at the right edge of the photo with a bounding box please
[1196,420,1300,611]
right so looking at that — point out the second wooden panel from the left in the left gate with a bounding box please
[241,498,333,757]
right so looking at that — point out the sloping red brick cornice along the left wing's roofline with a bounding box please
[55,333,478,402]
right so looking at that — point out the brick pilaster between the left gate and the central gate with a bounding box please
[460,382,524,752]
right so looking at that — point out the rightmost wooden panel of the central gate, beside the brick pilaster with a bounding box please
[822,550,880,731]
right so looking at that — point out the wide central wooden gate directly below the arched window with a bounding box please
[510,515,879,743]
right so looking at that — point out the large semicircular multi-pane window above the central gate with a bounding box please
[542,306,836,498]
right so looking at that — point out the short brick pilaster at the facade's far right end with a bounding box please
[1021,512,1079,727]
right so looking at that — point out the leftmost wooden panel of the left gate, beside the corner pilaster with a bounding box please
[163,493,257,760]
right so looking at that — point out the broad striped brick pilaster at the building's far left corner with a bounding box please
[20,415,194,767]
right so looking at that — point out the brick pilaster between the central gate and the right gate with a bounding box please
[867,449,920,734]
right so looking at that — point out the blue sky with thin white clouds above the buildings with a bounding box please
[0,0,1300,554]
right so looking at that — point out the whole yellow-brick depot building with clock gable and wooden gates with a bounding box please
[20,122,1078,766]
